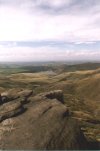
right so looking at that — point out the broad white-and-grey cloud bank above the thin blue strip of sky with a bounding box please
[0,0,100,42]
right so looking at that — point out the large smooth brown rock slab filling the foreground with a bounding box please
[0,91,94,150]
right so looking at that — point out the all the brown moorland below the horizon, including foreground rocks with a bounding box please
[0,62,100,150]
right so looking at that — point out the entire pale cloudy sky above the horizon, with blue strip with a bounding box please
[0,0,100,61]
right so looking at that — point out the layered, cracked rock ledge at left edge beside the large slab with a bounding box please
[0,90,33,122]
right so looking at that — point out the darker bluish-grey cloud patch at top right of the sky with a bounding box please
[31,0,100,15]
